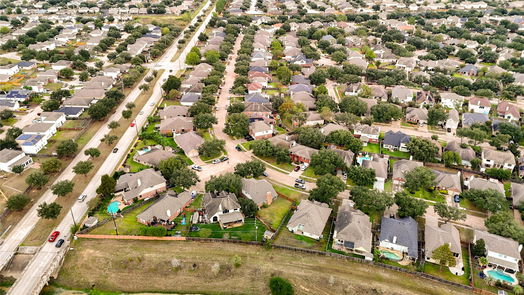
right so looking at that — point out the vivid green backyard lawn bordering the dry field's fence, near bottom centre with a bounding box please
[189,218,266,241]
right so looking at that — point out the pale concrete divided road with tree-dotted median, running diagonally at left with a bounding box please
[4,3,212,294]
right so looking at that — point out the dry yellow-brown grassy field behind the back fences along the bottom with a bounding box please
[53,239,474,295]
